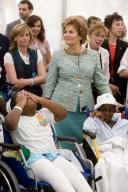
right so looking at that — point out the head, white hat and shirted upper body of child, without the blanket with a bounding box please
[83,93,128,144]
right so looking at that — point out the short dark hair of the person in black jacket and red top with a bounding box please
[104,12,123,29]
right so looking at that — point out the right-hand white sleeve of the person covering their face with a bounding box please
[39,108,55,125]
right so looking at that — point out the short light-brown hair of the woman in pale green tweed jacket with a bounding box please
[62,16,87,44]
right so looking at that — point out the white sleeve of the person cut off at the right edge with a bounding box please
[117,48,128,73]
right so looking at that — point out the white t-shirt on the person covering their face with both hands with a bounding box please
[11,108,57,153]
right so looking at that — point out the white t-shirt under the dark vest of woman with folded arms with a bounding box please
[4,50,43,65]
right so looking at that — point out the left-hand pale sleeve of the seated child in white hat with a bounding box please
[83,117,96,133]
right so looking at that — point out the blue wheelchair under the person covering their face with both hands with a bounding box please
[0,119,95,192]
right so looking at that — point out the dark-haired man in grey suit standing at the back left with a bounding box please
[6,0,33,39]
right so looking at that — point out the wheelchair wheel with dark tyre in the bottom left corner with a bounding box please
[0,161,20,192]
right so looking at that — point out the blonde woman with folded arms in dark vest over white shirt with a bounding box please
[4,23,46,96]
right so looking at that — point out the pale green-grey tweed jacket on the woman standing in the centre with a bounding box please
[44,49,111,112]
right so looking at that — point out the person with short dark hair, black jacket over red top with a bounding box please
[102,13,128,104]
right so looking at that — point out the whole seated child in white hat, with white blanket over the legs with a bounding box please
[83,93,128,192]
